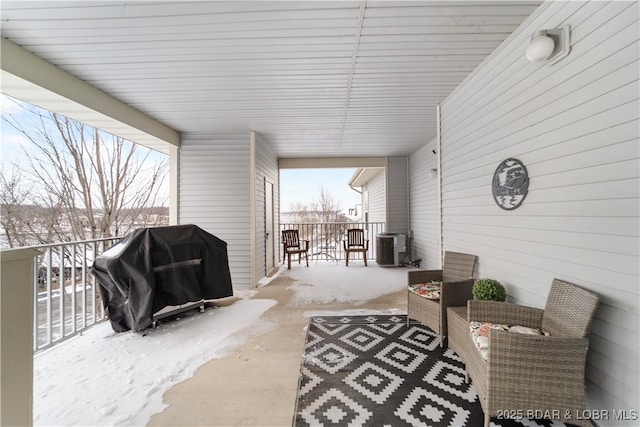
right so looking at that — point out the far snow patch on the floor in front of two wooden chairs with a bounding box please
[288,260,407,306]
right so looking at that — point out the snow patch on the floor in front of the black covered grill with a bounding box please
[33,291,276,426]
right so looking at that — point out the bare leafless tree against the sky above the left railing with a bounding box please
[2,96,168,243]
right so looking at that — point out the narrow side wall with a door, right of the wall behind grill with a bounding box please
[255,134,280,280]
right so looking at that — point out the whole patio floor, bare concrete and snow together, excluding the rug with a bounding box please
[34,261,410,426]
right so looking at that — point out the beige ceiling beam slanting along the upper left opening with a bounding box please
[0,38,180,154]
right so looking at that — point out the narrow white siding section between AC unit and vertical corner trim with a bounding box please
[409,139,441,270]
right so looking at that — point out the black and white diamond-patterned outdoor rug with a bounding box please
[293,315,564,427]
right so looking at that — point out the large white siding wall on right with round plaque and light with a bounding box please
[440,2,640,425]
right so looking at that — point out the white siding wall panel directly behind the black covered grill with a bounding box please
[179,133,252,288]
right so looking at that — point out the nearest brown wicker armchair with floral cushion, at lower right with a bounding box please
[460,279,599,426]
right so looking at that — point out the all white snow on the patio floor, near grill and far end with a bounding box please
[33,263,406,426]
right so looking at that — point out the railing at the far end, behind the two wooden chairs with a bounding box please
[280,222,386,260]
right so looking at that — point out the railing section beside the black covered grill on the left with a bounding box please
[32,237,121,351]
